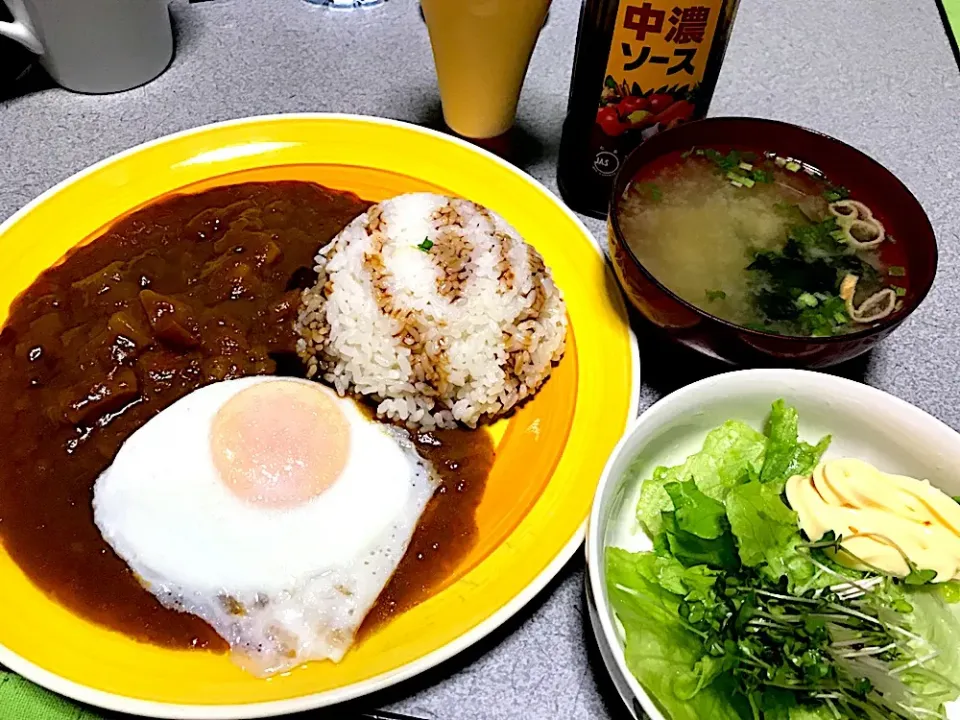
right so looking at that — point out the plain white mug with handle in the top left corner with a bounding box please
[0,0,173,93]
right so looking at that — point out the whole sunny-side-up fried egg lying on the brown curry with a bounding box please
[93,377,439,676]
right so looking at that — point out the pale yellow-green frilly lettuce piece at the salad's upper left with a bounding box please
[628,420,767,538]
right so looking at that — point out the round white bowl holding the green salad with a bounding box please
[586,370,960,720]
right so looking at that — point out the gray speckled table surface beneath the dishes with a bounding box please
[0,0,960,720]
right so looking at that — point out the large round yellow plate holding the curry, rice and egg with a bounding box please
[0,115,639,719]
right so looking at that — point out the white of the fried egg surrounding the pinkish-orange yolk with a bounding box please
[93,377,438,674]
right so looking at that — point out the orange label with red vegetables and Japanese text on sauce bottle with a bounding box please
[591,0,735,177]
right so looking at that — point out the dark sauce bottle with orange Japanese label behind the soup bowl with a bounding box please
[557,0,739,218]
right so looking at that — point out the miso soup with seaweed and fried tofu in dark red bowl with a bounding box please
[618,148,907,337]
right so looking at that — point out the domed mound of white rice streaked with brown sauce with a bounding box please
[296,193,567,429]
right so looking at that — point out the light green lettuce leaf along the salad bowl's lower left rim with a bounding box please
[606,548,752,720]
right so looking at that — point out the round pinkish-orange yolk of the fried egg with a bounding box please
[210,380,350,508]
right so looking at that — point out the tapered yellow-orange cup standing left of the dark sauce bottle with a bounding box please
[420,0,550,138]
